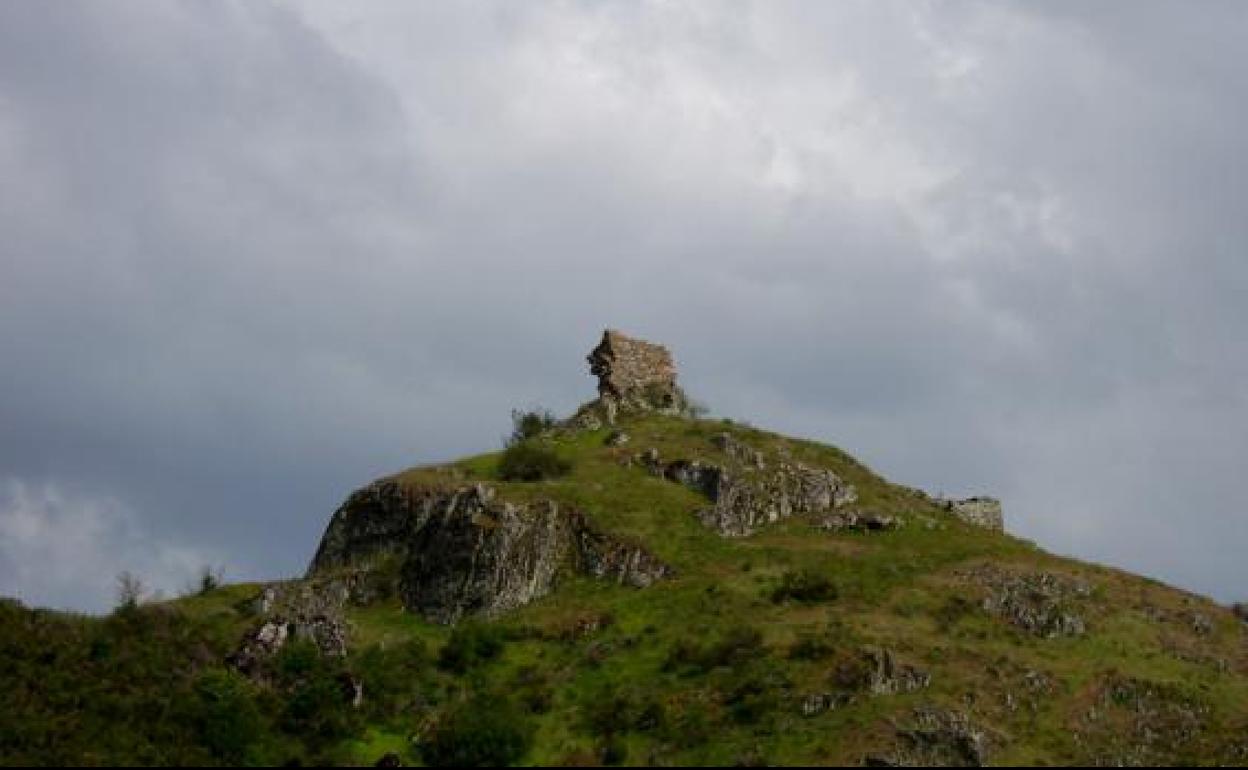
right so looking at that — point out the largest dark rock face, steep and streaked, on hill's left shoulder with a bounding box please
[308,480,673,623]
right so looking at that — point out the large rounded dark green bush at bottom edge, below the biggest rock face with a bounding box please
[421,696,533,768]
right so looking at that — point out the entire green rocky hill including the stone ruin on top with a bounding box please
[0,332,1248,765]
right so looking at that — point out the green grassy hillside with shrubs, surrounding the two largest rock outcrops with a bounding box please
[0,416,1248,765]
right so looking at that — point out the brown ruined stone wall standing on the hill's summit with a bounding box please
[588,329,684,413]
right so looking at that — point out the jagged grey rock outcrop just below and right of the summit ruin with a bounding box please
[638,444,857,537]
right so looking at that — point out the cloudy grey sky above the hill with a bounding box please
[0,0,1248,612]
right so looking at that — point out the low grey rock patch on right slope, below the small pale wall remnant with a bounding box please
[962,567,1092,639]
